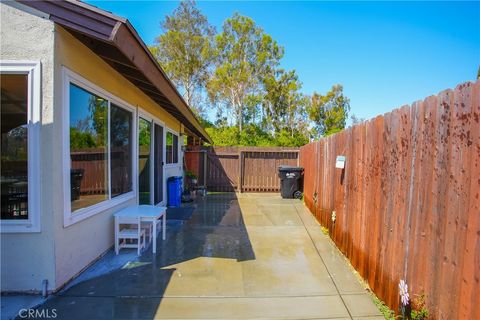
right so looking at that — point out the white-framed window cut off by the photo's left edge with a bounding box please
[0,62,40,232]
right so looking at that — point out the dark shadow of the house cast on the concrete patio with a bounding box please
[30,193,255,319]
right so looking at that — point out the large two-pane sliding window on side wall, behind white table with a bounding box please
[66,69,135,225]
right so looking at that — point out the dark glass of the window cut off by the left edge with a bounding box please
[0,74,28,220]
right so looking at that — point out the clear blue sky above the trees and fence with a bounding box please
[87,1,480,119]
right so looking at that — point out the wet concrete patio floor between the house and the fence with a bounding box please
[31,194,383,319]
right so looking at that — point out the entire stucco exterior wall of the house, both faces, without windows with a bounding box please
[0,2,188,292]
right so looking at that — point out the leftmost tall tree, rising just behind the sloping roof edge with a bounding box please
[150,1,215,115]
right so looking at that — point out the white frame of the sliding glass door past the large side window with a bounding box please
[135,109,167,206]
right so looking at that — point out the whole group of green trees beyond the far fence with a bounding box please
[151,1,350,146]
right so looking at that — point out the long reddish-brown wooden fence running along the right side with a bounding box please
[300,81,480,319]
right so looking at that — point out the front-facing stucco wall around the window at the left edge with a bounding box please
[0,2,56,291]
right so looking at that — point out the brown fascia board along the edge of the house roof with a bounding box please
[18,0,212,143]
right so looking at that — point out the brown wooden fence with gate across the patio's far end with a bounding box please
[185,147,299,192]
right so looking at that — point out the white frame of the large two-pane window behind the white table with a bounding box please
[62,66,138,227]
